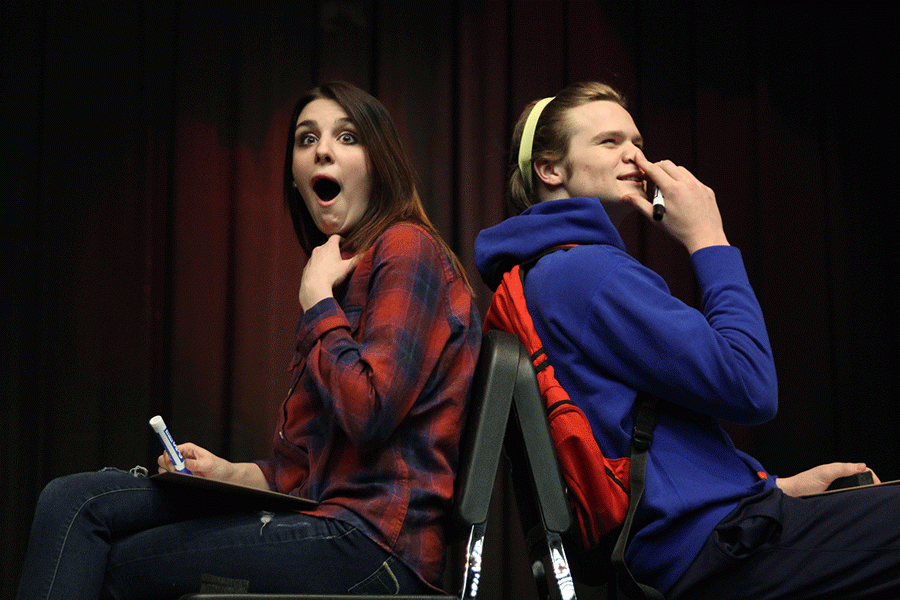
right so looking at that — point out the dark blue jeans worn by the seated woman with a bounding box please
[18,469,425,600]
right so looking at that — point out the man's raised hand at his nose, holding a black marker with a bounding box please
[623,151,728,254]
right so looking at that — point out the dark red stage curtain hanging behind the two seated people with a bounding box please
[0,0,900,598]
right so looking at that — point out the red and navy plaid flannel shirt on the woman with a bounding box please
[258,224,481,587]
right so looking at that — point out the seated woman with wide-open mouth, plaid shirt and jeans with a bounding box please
[19,82,481,600]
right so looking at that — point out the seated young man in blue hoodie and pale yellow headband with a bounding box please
[475,83,900,600]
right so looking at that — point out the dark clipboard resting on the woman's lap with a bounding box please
[150,471,319,511]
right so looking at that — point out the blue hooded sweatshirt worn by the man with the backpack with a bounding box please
[475,198,778,593]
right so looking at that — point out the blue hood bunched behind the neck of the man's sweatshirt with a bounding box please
[475,198,625,290]
